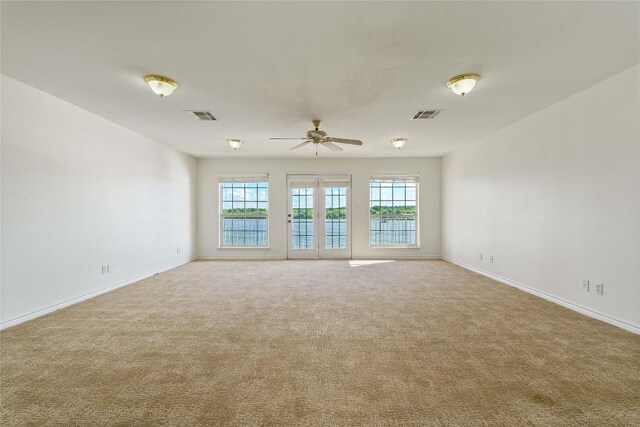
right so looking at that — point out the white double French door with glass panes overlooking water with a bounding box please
[287,175,351,259]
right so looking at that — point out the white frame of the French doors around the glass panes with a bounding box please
[285,173,353,259]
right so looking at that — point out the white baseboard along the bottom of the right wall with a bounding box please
[441,256,640,335]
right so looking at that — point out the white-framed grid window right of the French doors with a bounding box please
[369,175,418,247]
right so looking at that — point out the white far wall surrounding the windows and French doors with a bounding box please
[198,157,442,259]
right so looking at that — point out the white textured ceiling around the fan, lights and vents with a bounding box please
[1,1,640,157]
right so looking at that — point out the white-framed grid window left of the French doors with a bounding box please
[220,175,269,247]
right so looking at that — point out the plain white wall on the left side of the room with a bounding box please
[0,76,196,326]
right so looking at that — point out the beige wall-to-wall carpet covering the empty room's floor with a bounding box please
[0,261,640,426]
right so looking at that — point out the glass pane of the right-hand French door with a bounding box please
[324,187,347,249]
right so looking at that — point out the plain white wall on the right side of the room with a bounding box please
[443,65,640,330]
